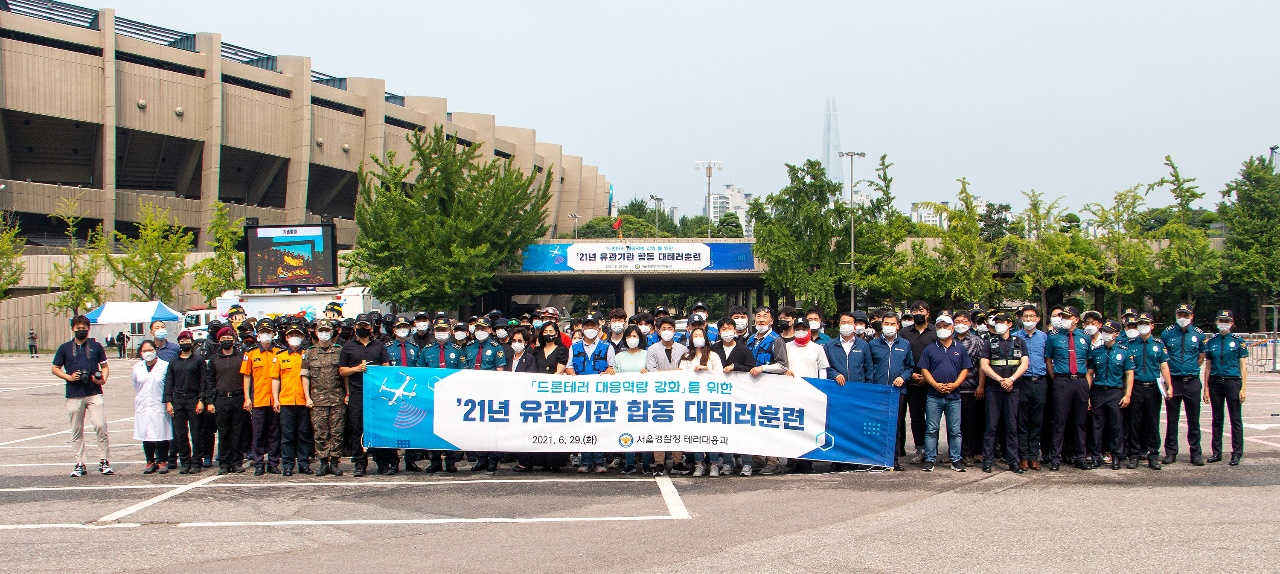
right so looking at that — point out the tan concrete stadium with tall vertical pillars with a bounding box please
[0,0,609,252]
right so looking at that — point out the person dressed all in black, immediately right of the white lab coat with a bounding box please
[163,331,209,474]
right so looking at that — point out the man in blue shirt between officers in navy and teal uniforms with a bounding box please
[1014,305,1048,470]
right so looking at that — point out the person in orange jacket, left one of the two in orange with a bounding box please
[241,319,280,477]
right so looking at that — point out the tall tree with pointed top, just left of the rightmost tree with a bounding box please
[1147,155,1222,310]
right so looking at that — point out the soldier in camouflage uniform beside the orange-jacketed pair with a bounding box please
[302,319,347,477]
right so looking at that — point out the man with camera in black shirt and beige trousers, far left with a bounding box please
[52,315,115,477]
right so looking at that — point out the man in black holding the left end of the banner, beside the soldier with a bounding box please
[338,313,394,478]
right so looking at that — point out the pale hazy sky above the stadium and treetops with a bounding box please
[82,0,1280,215]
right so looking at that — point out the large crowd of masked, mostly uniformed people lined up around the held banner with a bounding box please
[67,295,1248,477]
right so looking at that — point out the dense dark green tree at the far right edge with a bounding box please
[1217,156,1280,332]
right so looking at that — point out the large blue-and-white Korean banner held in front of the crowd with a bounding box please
[364,366,899,466]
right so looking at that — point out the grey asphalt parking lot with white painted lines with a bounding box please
[0,355,1280,573]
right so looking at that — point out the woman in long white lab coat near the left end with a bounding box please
[133,340,173,474]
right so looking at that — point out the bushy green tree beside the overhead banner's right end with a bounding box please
[746,160,849,314]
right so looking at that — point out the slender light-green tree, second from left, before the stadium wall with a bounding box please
[49,192,106,315]
